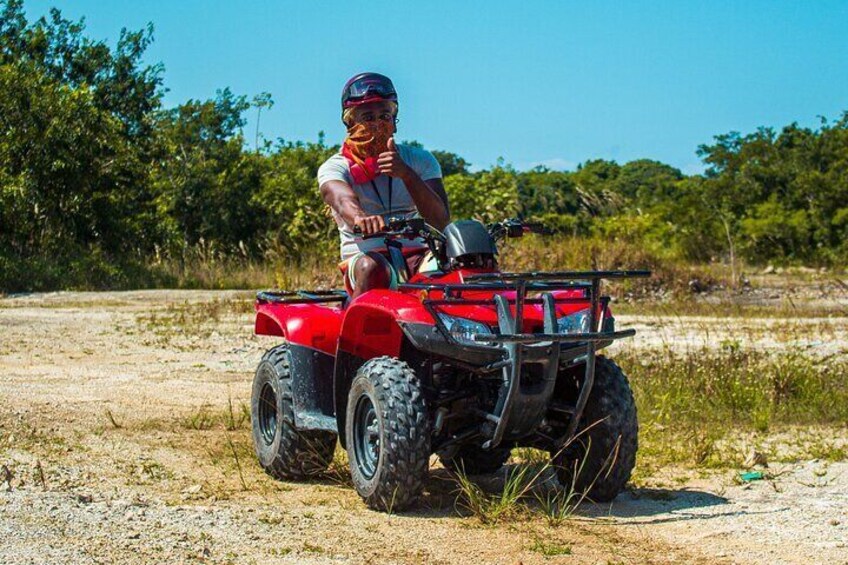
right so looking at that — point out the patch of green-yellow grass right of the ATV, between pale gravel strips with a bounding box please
[617,344,848,477]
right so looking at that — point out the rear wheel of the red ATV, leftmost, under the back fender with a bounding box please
[250,344,337,480]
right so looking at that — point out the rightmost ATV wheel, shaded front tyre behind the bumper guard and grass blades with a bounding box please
[553,355,639,502]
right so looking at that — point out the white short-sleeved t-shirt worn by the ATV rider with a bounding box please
[318,145,442,259]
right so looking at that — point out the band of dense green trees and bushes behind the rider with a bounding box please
[0,0,848,291]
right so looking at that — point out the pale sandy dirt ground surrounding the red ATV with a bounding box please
[0,291,848,564]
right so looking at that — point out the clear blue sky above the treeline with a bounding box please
[25,0,848,172]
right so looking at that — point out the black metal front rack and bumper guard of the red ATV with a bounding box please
[400,270,651,449]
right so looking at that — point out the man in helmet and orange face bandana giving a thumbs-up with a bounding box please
[318,73,450,298]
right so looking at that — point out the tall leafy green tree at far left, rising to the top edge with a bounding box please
[0,0,161,287]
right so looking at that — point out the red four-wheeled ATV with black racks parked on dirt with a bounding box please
[251,219,650,510]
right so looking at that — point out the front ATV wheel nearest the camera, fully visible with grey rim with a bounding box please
[345,357,430,512]
